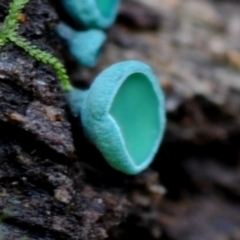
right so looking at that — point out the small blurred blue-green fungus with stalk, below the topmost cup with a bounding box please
[56,23,106,67]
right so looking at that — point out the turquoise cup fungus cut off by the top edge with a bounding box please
[61,0,120,29]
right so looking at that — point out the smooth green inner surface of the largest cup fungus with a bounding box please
[109,73,161,166]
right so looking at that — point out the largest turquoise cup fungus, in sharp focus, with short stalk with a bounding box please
[67,61,166,174]
